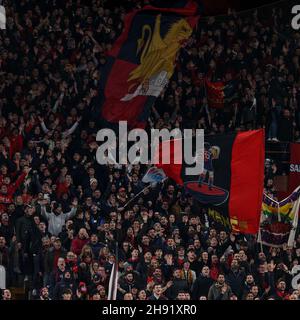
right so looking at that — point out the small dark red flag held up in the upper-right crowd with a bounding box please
[205,79,238,109]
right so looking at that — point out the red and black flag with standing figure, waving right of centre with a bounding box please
[156,129,264,234]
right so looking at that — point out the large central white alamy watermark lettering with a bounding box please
[96,121,204,175]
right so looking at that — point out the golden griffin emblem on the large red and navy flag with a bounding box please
[121,15,193,101]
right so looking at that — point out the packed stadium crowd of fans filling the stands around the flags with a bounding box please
[0,0,300,300]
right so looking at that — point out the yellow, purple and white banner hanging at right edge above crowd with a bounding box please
[258,186,300,248]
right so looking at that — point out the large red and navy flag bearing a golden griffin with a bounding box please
[100,0,198,128]
